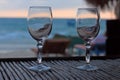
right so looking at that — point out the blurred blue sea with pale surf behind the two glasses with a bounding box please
[0,18,106,53]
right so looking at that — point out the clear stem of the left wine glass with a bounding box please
[37,40,43,64]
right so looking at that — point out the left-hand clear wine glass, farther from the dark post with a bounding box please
[27,6,52,71]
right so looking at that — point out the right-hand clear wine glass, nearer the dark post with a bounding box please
[76,8,100,71]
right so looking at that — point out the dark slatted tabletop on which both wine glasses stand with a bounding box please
[0,57,120,80]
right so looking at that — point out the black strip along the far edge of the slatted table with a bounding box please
[0,56,120,61]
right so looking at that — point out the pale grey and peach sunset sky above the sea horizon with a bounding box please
[0,0,115,18]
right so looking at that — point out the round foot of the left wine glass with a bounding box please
[28,64,51,72]
